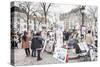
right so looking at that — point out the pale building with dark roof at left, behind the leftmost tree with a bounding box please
[11,2,44,33]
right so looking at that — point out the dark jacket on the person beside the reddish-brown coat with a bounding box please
[31,37,42,49]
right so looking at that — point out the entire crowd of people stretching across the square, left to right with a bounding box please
[11,30,97,61]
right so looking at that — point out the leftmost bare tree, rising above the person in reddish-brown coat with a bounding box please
[19,2,36,31]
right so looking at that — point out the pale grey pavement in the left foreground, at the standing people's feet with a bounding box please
[15,49,63,65]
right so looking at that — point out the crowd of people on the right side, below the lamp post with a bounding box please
[63,30,97,53]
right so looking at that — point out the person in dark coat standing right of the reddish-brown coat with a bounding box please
[31,33,42,61]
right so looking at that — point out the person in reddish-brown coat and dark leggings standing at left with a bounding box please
[22,31,30,57]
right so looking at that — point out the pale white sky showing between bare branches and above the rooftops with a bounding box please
[15,1,95,18]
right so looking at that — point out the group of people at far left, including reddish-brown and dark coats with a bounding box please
[11,31,43,61]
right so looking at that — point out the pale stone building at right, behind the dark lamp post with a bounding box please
[60,7,95,30]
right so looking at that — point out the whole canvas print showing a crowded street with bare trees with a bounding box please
[10,1,98,66]
